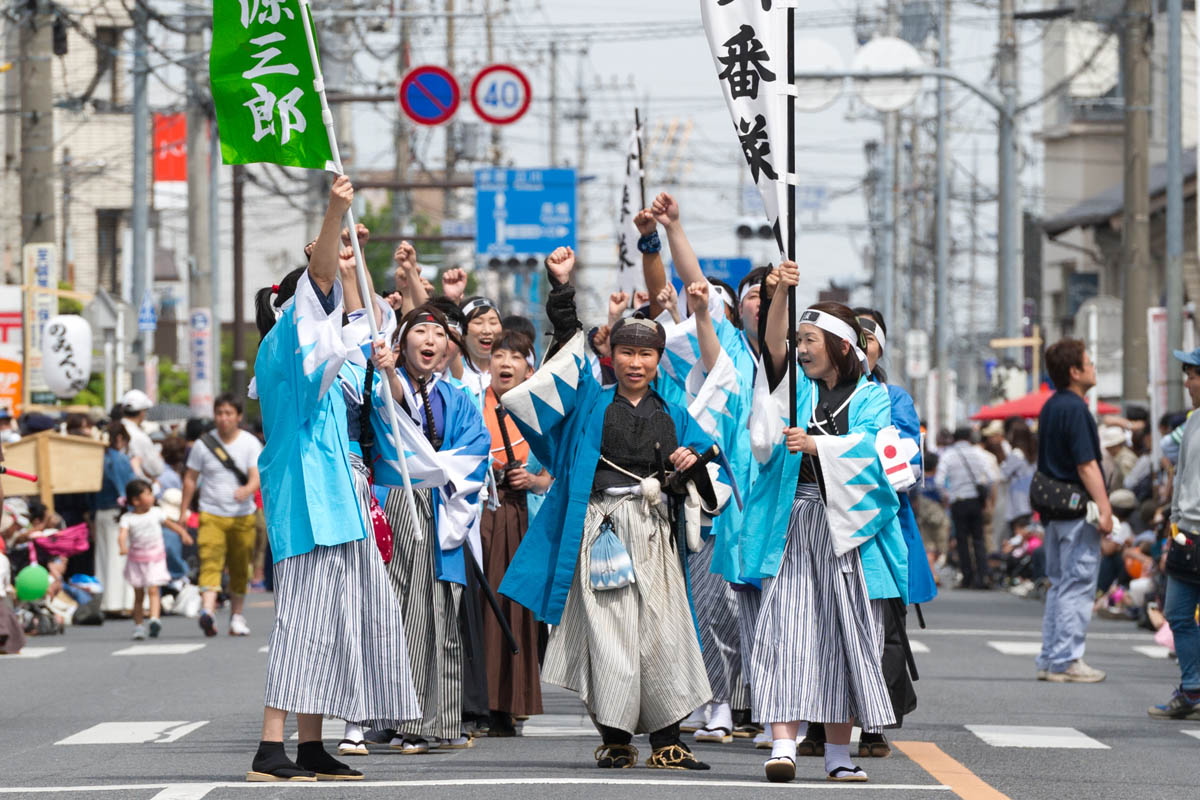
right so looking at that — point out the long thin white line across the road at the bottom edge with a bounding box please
[0,777,950,800]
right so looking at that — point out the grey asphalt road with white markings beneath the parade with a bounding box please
[0,591,1200,800]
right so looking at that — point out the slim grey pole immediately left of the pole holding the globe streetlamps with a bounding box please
[934,0,950,429]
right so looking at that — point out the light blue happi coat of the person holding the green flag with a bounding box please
[251,273,366,563]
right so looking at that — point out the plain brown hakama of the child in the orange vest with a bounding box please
[480,491,542,716]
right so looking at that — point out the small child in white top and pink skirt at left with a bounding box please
[118,479,187,640]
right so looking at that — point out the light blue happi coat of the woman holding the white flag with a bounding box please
[740,367,908,603]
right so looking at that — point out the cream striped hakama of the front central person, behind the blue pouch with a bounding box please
[542,494,713,733]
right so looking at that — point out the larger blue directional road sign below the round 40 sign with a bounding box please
[475,169,576,265]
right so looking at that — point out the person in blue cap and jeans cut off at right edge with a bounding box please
[1148,348,1200,720]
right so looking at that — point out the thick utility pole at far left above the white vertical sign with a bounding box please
[18,0,54,247]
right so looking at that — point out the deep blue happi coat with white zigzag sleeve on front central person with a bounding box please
[499,332,728,625]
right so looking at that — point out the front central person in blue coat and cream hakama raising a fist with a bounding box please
[499,247,730,770]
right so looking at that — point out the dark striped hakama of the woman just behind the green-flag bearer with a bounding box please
[384,489,463,739]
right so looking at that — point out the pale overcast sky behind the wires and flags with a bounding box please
[145,0,1056,340]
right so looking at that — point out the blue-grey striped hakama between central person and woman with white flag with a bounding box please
[688,537,748,708]
